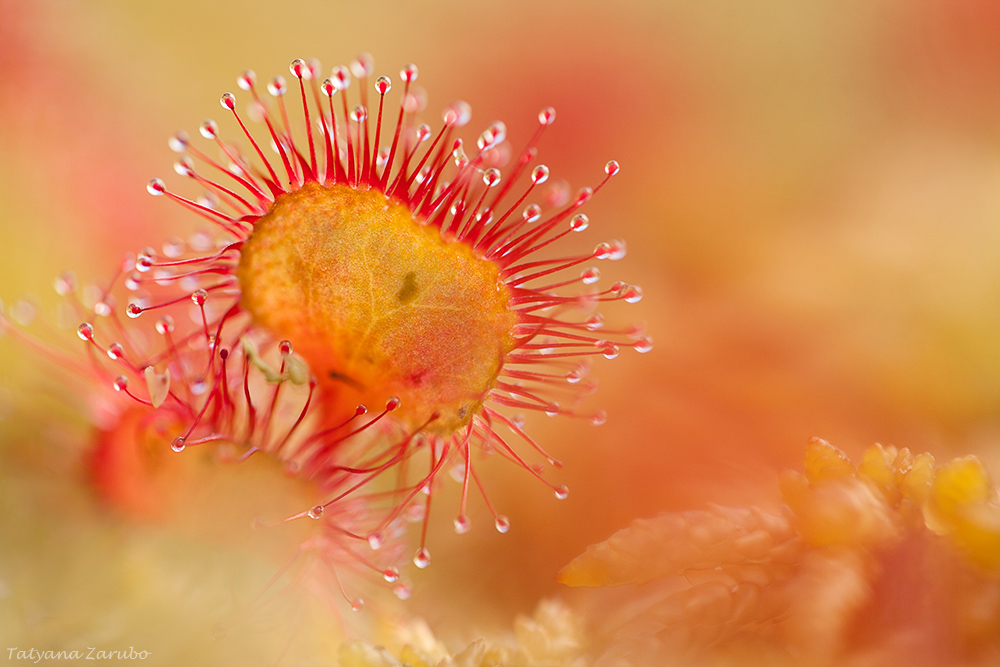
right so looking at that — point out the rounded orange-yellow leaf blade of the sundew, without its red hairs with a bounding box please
[237,183,517,434]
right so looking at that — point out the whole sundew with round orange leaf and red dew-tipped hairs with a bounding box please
[4,55,652,610]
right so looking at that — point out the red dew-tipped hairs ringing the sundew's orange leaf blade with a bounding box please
[61,57,652,579]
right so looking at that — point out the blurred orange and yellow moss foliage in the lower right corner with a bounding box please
[560,438,1000,665]
